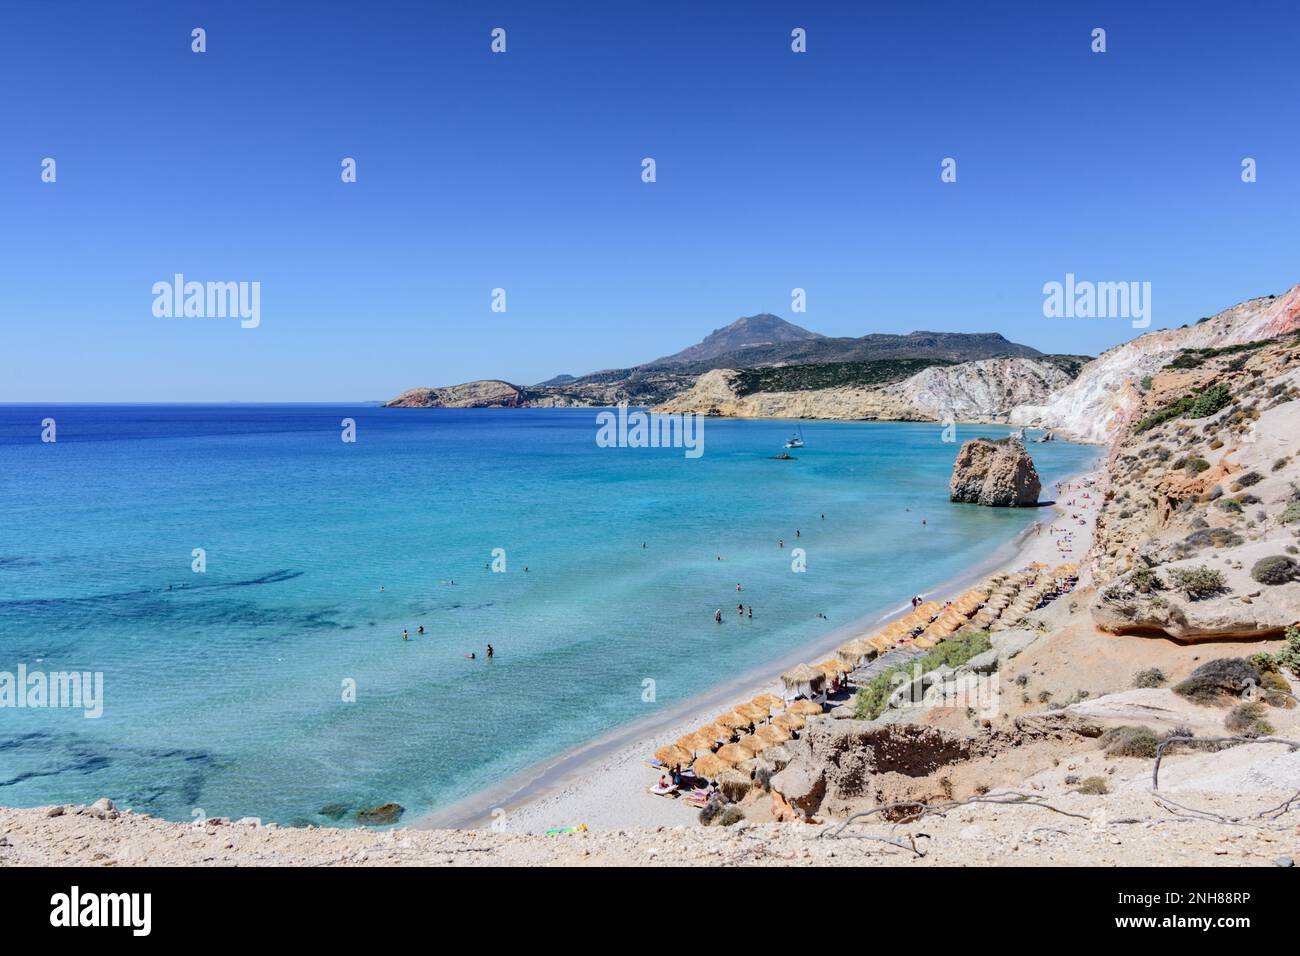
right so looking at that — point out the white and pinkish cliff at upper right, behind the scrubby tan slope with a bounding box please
[1010,286,1300,442]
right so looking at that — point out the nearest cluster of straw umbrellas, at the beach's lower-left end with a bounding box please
[654,693,822,779]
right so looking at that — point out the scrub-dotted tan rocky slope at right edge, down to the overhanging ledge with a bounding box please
[1089,329,1300,640]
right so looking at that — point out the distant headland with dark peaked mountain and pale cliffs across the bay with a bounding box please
[387,313,1089,429]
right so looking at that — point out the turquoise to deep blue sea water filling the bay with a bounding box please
[0,406,1097,823]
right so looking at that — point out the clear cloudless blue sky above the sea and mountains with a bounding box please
[0,0,1300,402]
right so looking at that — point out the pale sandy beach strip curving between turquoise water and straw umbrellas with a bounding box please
[412,471,1104,832]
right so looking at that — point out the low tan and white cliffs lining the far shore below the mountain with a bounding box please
[655,358,1070,421]
